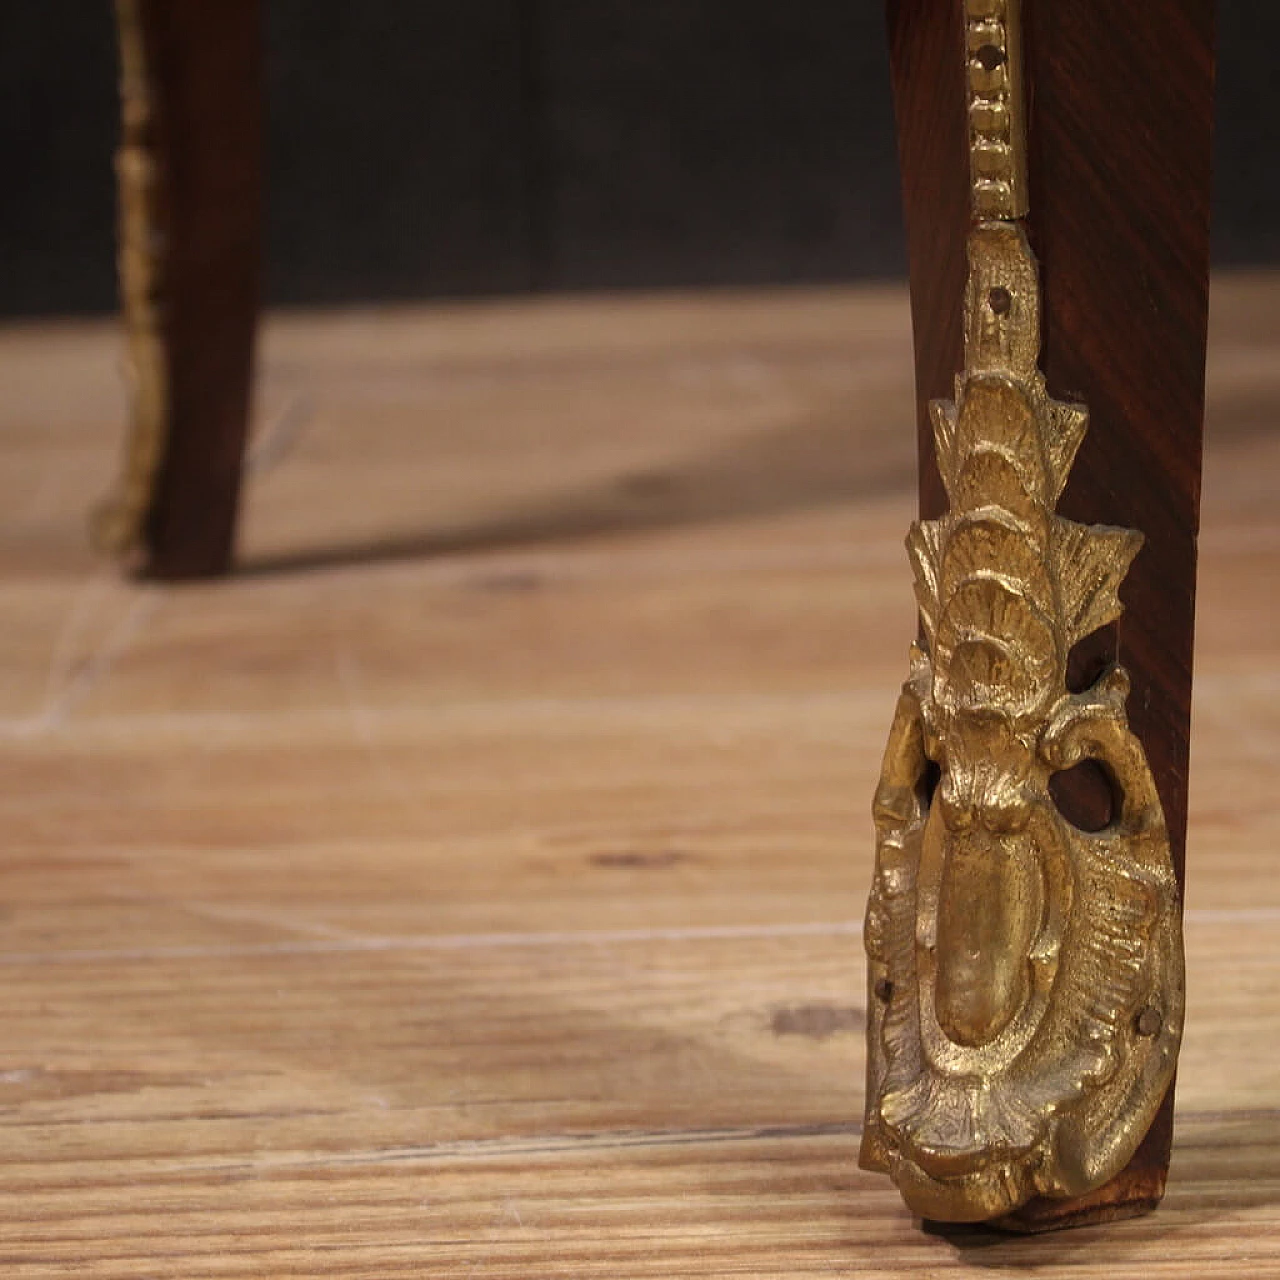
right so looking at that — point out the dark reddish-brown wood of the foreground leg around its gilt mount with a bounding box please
[864,0,1215,1231]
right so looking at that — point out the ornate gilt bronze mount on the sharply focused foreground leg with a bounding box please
[861,0,1184,1221]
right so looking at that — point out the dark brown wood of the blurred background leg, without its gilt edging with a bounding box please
[129,0,262,579]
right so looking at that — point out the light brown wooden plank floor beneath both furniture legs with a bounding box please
[0,276,1280,1280]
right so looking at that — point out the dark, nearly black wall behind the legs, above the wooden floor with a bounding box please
[0,0,1280,315]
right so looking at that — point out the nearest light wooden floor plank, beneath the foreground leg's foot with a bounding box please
[5,1117,1280,1280]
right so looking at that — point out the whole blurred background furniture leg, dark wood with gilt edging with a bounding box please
[95,0,262,579]
